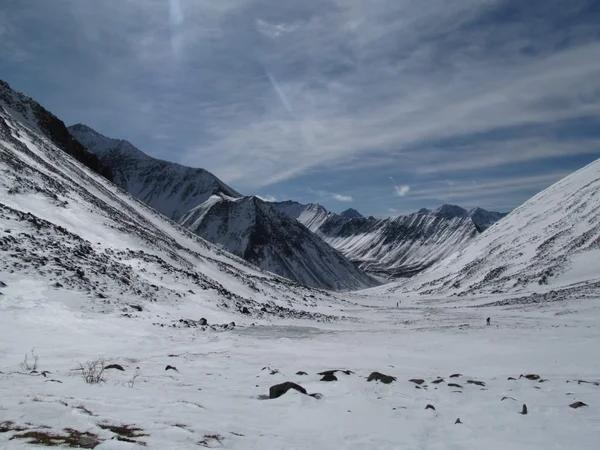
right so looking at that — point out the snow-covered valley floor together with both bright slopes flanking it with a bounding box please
[0,80,600,450]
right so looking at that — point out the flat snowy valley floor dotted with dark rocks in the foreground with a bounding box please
[0,294,600,450]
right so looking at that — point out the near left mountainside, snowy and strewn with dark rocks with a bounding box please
[0,81,346,320]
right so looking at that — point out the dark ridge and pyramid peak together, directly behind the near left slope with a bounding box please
[69,124,377,290]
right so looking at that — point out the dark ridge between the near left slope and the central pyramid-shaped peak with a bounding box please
[69,124,241,220]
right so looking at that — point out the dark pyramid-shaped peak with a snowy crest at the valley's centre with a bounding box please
[181,195,376,290]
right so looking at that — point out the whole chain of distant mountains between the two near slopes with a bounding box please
[69,119,504,284]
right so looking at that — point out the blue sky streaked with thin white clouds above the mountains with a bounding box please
[0,0,600,217]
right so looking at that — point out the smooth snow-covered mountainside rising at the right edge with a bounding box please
[386,160,600,299]
